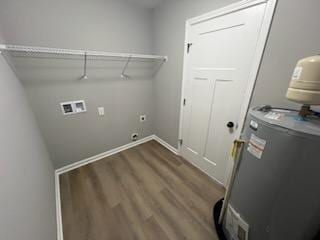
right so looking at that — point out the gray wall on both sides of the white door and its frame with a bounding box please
[154,0,320,147]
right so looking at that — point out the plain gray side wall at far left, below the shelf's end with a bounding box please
[0,54,56,240]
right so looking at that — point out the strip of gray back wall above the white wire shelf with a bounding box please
[0,0,152,53]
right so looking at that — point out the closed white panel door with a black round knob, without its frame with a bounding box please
[181,4,266,183]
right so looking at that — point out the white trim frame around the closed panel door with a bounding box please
[178,0,278,186]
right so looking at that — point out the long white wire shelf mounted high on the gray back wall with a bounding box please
[0,44,168,62]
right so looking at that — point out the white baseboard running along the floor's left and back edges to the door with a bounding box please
[55,135,178,240]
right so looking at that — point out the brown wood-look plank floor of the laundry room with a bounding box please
[60,141,224,240]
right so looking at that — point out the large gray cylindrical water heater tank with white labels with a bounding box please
[224,108,320,240]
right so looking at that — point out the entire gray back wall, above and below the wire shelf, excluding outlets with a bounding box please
[0,0,154,168]
